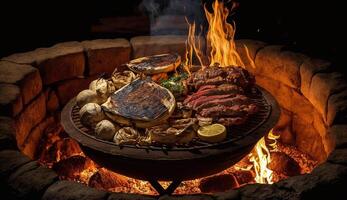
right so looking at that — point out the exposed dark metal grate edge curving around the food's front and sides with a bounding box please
[71,87,271,153]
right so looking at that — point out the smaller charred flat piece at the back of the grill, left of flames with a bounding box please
[126,54,181,74]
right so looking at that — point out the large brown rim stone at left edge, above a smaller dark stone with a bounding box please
[0,61,42,104]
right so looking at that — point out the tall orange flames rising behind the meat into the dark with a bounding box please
[185,0,244,71]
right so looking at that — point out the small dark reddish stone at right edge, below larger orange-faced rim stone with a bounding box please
[326,90,347,126]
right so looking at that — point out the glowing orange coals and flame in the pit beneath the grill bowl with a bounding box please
[39,122,317,195]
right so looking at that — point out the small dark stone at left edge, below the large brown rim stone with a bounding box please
[0,83,23,117]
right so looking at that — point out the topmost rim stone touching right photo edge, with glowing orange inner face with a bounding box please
[308,72,347,121]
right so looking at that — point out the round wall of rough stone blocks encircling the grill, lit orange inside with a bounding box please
[0,36,347,200]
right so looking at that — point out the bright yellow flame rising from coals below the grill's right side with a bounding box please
[249,130,280,184]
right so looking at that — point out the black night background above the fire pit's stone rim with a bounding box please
[0,0,347,71]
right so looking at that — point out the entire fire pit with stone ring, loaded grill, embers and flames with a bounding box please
[0,1,347,200]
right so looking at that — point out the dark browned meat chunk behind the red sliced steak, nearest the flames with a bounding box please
[188,66,255,90]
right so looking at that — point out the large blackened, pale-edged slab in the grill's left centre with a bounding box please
[102,79,175,128]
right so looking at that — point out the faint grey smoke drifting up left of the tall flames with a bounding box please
[139,0,204,35]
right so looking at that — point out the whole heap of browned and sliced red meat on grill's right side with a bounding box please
[183,66,257,126]
